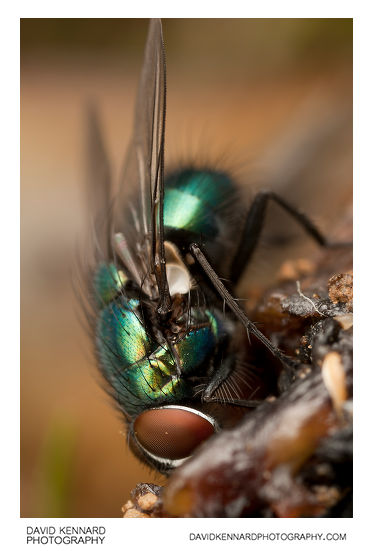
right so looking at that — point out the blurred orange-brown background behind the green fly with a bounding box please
[21,19,352,517]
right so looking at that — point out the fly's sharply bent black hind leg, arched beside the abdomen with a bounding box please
[230,191,351,284]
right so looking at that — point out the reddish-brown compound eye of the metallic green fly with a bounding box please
[133,406,215,461]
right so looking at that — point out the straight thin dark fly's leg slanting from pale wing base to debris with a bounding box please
[189,243,298,369]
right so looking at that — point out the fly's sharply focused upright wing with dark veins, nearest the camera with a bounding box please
[115,19,169,311]
